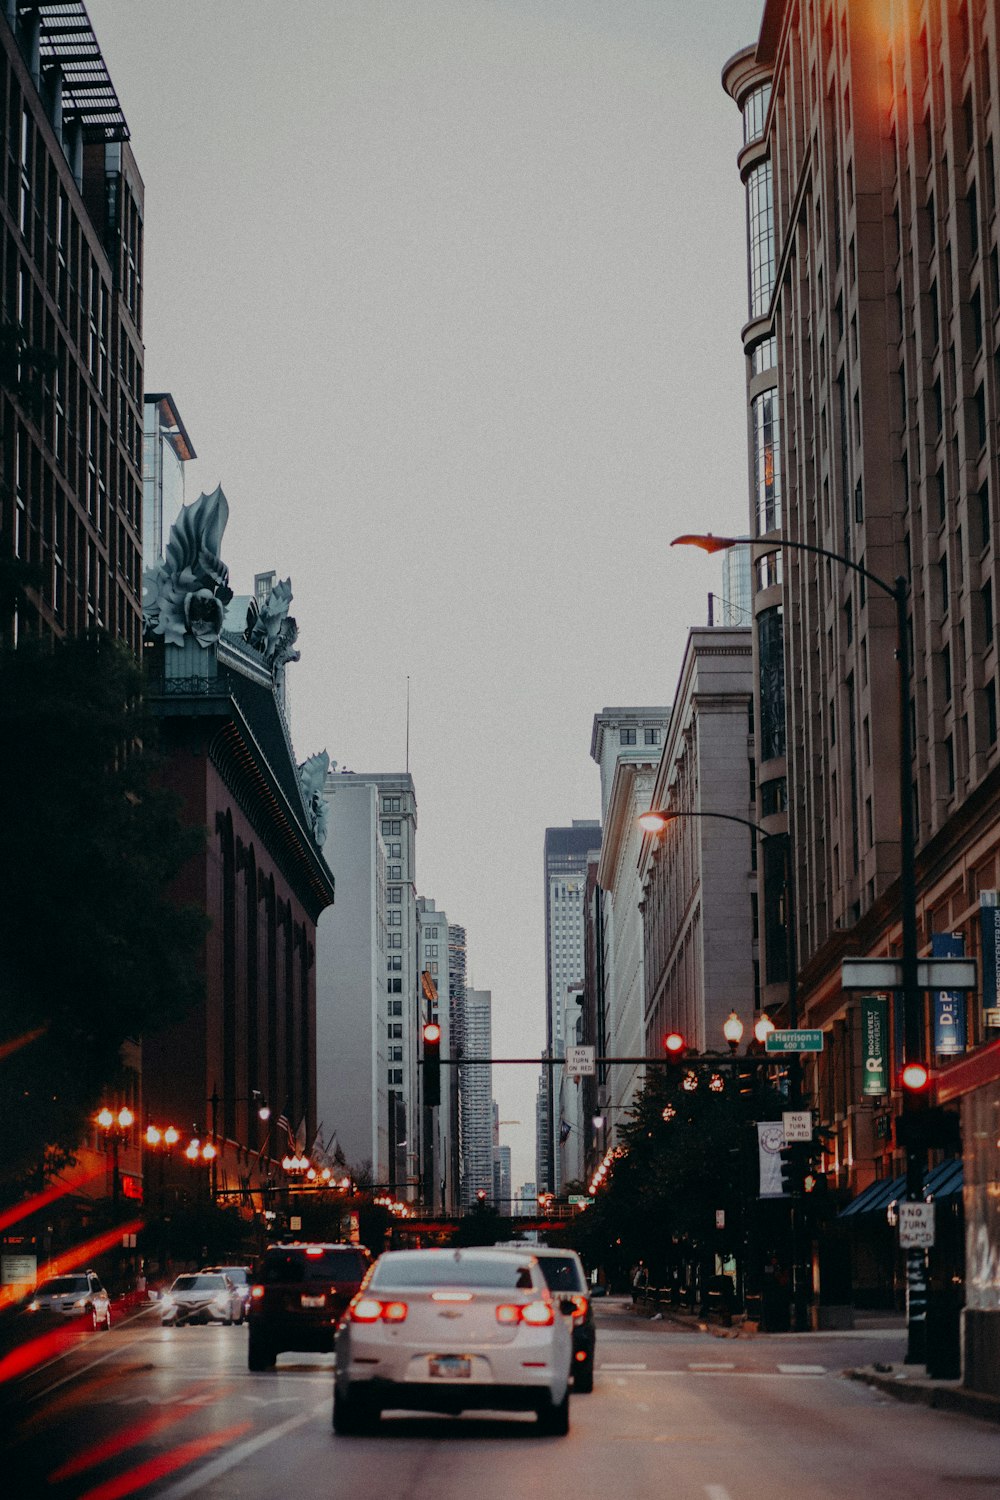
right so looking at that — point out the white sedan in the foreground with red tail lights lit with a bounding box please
[333,1247,573,1437]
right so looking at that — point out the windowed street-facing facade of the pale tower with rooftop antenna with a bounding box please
[327,771,421,1199]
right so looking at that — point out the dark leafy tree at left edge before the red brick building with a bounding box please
[0,636,207,1200]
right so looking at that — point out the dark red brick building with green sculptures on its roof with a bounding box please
[142,489,334,1209]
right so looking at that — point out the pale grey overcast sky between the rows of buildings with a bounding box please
[87,0,763,1187]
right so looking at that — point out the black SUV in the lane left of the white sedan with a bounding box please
[247,1244,372,1370]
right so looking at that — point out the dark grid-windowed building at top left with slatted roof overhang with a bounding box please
[0,0,142,656]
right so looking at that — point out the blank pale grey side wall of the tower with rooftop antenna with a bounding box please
[316,771,389,1187]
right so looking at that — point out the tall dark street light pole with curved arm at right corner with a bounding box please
[670,533,927,1365]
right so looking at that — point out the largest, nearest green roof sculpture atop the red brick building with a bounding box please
[142,485,232,650]
